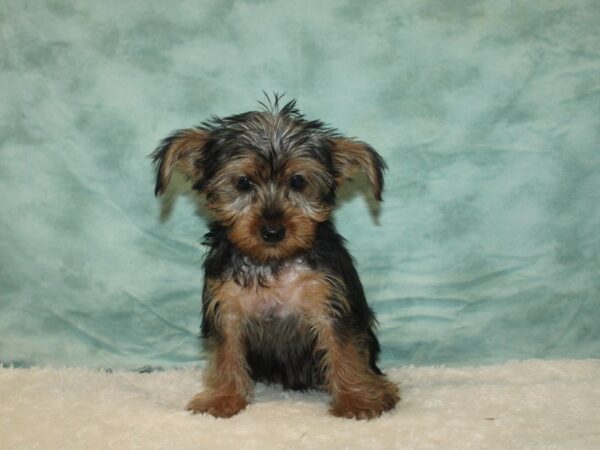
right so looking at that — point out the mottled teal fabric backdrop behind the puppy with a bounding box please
[0,0,600,369]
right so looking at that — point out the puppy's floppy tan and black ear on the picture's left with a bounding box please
[152,128,209,196]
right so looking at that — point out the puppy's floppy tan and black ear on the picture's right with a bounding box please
[331,138,386,201]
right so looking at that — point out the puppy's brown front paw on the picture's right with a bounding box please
[329,379,400,420]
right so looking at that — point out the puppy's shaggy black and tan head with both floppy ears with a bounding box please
[153,97,385,262]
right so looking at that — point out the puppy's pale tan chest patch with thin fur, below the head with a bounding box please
[238,261,326,321]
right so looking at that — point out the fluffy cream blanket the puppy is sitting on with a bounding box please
[0,360,600,450]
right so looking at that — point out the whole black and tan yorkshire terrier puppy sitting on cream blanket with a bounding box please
[152,96,400,419]
